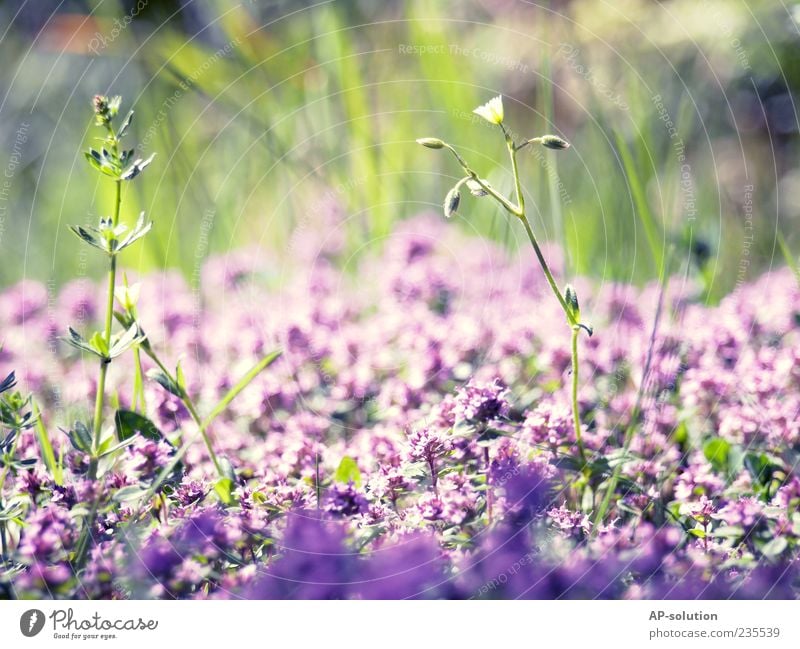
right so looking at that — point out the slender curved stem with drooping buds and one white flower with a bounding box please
[417,95,593,465]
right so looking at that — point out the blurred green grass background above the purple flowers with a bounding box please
[0,0,800,302]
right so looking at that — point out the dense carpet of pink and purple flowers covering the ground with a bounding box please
[0,215,800,599]
